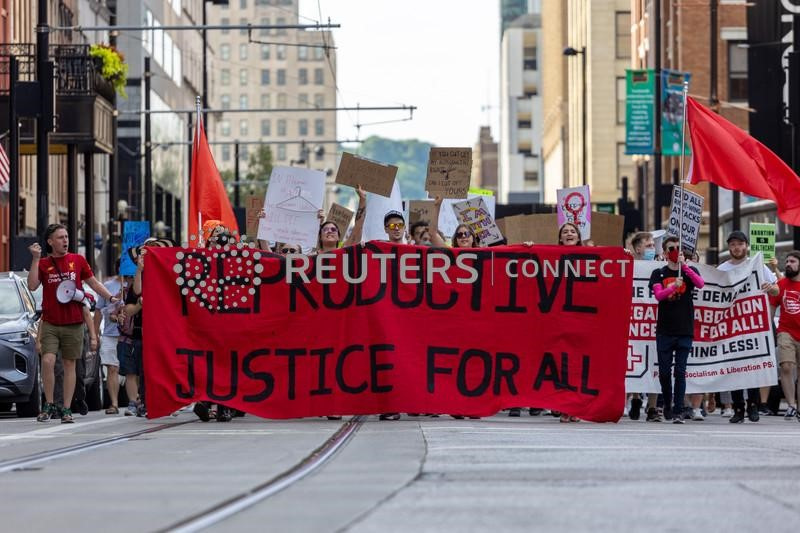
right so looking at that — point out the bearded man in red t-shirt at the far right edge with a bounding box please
[762,250,800,422]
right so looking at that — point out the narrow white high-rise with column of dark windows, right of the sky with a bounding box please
[497,8,543,204]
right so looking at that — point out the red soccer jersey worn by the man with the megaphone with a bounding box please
[39,254,94,326]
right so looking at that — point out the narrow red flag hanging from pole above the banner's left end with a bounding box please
[189,119,239,246]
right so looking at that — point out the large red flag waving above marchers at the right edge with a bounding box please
[686,98,800,226]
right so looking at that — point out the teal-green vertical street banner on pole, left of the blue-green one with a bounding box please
[625,69,656,155]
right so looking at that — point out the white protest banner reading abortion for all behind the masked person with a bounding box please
[625,255,777,394]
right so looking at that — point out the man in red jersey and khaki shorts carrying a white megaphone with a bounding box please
[28,224,117,424]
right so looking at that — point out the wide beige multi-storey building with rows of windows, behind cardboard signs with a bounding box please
[208,0,337,202]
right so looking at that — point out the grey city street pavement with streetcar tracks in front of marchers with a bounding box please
[0,411,800,532]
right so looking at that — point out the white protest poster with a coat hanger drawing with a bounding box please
[258,167,325,251]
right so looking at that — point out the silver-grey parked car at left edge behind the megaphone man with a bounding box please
[0,272,42,417]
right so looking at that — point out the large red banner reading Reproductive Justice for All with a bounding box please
[143,242,632,421]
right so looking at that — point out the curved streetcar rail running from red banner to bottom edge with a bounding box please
[157,416,366,533]
